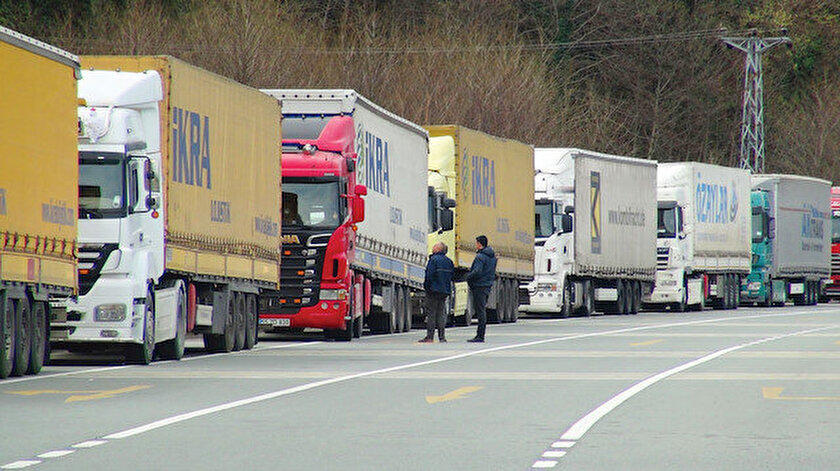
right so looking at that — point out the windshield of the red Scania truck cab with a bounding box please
[283,179,345,228]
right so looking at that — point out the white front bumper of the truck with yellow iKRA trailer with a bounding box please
[51,277,145,343]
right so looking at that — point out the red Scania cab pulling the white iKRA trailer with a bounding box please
[260,115,369,341]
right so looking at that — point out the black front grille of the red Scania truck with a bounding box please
[260,240,327,314]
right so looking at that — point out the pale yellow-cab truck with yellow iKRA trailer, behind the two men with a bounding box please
[427,125,534,325]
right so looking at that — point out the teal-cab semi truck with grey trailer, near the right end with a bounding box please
[741,175,831,306]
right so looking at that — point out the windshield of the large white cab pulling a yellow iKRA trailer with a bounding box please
[79,152,127,219]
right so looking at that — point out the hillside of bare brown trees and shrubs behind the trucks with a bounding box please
[0,0,840,181]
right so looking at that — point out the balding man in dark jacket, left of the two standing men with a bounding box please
[420,242,455,343]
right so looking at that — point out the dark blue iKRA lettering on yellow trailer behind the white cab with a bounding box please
[172,107,210,189]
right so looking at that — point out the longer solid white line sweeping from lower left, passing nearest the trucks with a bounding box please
[104,313,824,440]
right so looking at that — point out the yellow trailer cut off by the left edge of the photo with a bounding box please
[0,27,79,378]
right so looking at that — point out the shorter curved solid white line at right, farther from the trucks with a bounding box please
[560,325,838,440]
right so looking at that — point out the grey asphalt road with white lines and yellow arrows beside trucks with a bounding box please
[0,305,840,470]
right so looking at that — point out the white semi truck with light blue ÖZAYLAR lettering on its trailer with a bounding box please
[644,162,752,311]
